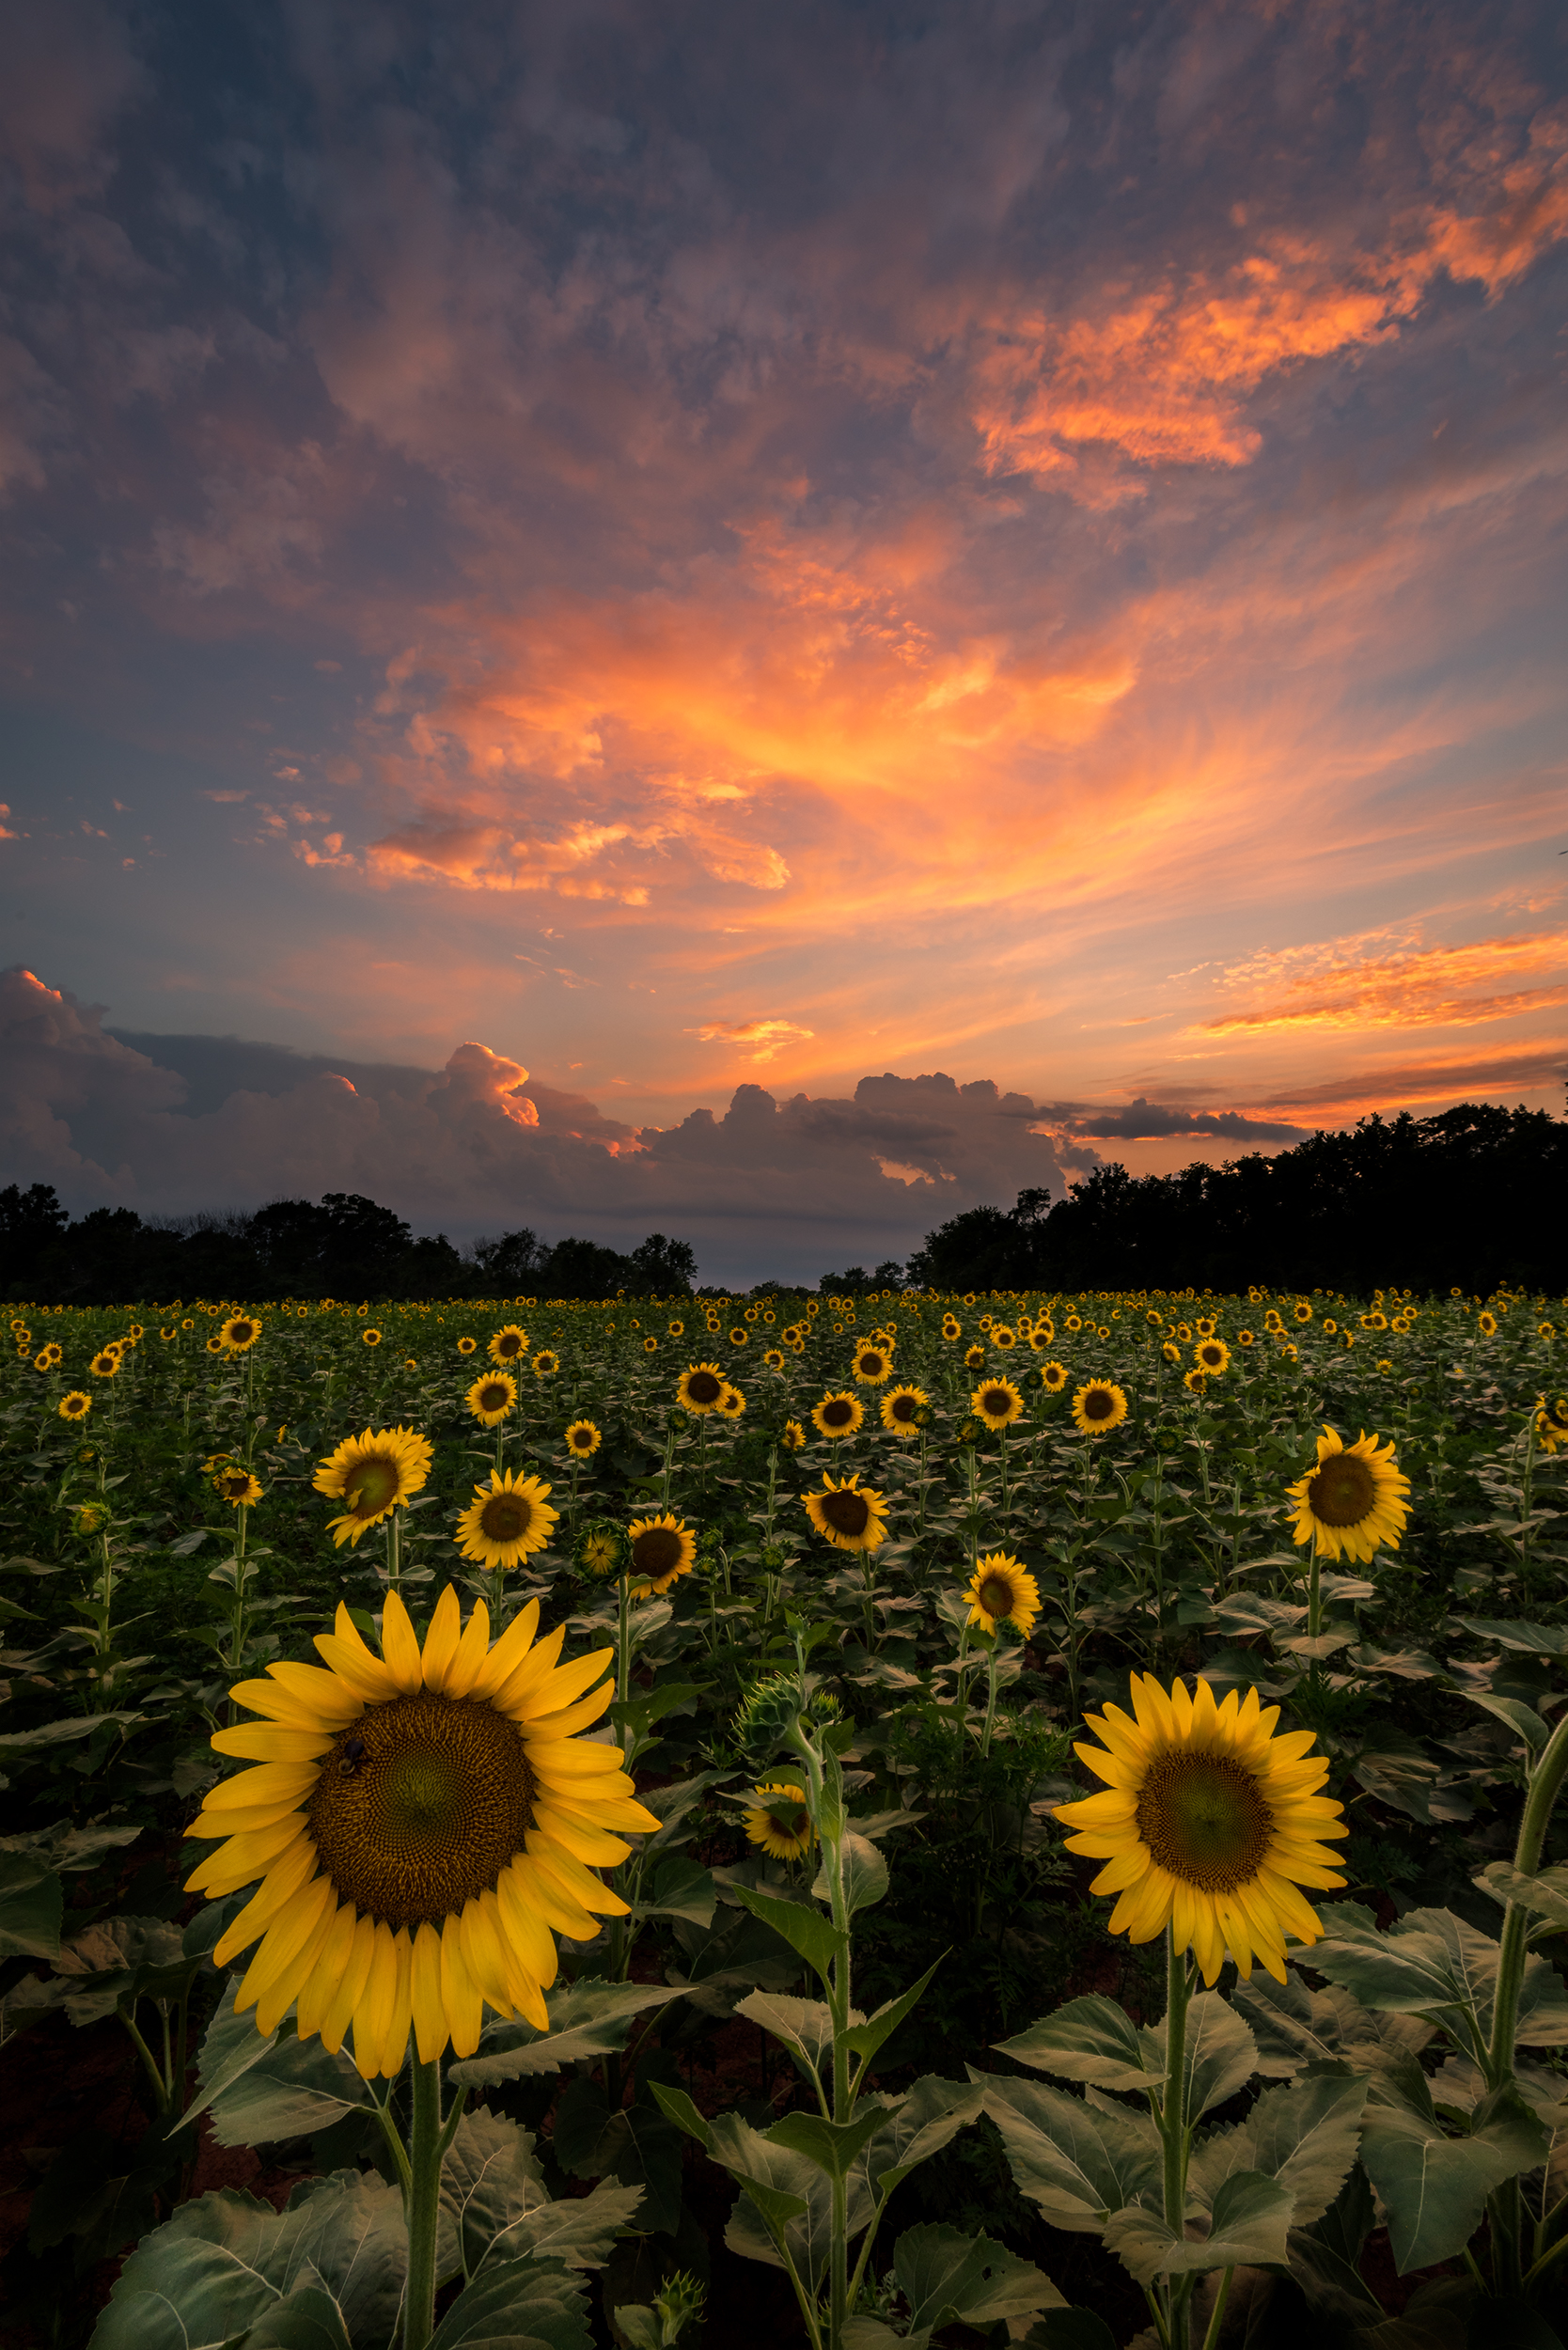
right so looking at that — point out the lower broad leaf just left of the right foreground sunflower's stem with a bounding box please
[971,2076,1161,2235]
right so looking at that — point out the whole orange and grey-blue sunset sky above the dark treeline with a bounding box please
[0,0,1568,1281]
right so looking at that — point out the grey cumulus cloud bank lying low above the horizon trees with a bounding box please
[0,971,1093,1281]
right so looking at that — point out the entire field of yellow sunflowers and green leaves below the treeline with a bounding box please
[0,1288,1568,2350]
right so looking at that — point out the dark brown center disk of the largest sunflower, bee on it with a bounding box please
[310,1690,534,1930]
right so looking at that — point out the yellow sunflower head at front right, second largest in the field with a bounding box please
[1056,1673,1349,1983]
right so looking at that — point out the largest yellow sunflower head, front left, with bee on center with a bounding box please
[186,1589,658,2080]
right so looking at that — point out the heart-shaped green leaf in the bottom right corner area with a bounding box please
[1361,2087,1549,2278]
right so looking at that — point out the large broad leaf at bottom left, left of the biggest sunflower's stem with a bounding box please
[92,2171,409,2350]
